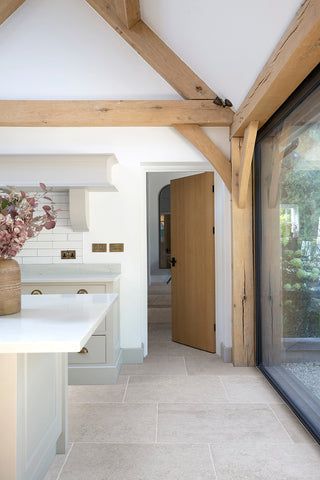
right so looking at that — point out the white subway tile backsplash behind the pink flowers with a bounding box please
[17,192,83,264]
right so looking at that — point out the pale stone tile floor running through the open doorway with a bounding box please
[45,294,320,480]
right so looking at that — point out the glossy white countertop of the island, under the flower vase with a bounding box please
[0,293,118,353]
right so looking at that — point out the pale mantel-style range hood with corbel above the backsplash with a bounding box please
[0,154,118,232]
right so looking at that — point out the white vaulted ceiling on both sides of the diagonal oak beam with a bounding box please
[0,0,301,107]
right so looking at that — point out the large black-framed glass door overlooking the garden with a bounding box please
[255,65,320,439]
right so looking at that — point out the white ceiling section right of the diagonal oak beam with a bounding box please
[140,0,302,108]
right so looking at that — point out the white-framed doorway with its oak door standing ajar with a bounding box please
[147,171,215,353]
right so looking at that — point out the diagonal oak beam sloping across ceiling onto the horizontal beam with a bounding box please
[87,0,216,100]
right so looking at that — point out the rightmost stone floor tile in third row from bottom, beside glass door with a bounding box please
[220,376,283,404]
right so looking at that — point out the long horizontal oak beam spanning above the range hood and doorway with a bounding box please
[0,100,232,127]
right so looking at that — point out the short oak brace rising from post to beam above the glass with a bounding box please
[239,121,259,208]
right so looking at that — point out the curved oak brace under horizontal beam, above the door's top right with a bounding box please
[174,124,231,192]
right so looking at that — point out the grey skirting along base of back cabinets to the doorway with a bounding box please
[68,345,143,385]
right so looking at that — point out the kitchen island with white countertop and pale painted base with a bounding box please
[0,293,118,480]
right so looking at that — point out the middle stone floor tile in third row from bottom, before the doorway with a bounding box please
[125,375,227,403]
